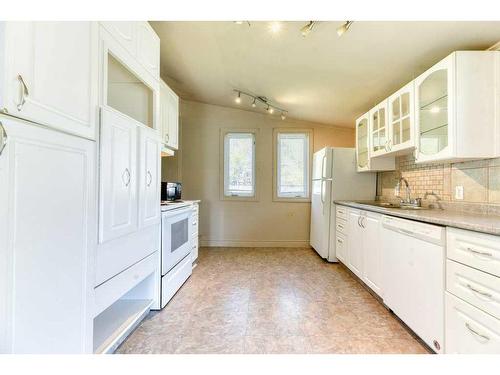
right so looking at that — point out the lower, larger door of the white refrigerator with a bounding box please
[310,180,332,258]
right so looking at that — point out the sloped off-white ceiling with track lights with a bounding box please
[151,21,500,127]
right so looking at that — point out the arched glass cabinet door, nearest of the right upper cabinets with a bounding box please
[415,59,452,161]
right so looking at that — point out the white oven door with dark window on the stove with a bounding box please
[161,206,192,276]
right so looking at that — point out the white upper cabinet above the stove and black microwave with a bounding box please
[160,81,179,150]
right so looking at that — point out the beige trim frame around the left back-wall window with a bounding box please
[219,128,259,202]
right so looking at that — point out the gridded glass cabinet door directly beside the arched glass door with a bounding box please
[387,82,415,152]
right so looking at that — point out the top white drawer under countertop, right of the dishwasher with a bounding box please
[446,228,500,276]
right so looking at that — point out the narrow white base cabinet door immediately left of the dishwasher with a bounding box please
[361,214,382,296]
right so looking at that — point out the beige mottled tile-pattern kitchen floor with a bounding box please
[117,248,427,354]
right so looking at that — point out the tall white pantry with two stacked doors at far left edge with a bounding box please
[0,22,98,353]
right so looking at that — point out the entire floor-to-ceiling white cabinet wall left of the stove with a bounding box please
[0,22,161,353]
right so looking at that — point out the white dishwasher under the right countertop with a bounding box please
[382,216,446,353]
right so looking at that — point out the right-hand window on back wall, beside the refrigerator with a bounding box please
[275,130,310,200]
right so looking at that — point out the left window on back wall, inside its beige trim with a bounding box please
[224,132,255,197]
